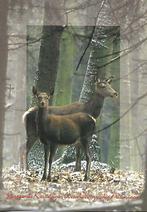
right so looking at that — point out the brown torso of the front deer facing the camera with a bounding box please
[39,113,95,144]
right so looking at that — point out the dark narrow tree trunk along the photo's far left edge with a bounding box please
[0,0,8,189]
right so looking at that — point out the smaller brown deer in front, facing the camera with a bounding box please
[33,88,96,181]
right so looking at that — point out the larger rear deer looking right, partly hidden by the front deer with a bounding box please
[23,78,118,171]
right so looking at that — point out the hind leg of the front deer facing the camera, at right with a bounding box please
[82,139,91,181]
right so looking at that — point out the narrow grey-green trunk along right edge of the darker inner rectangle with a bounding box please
[108,34,120,167]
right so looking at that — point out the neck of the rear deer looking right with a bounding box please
[85,93,104,118]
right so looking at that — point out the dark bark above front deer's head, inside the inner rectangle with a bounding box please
[37,26,63,94]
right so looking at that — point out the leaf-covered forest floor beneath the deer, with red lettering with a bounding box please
[0,162,144,209]
